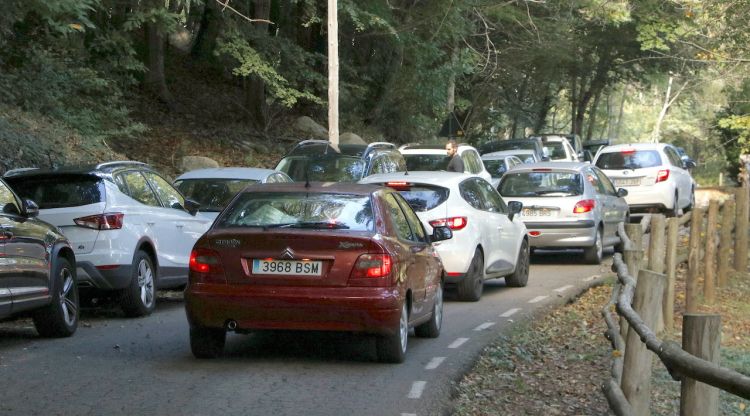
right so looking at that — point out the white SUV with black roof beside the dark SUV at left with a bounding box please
[5,161,211,316]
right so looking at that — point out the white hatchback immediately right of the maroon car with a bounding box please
[360,171,529,301]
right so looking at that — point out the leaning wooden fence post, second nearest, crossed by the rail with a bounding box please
[622,270,667,416]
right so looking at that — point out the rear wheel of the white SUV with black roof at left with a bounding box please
[120,250,157,318]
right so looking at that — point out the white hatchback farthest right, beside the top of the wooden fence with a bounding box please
[594,143,695,216]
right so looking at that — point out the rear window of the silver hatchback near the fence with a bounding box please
[498,171,583,197]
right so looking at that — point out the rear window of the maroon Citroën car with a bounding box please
[215,192,374,231]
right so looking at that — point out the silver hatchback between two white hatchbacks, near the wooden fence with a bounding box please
[498,162,629,264]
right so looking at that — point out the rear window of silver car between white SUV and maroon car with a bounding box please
[174,179,259,212]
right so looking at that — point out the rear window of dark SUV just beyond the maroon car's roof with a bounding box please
[276,153,365,182]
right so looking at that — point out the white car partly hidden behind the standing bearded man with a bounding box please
[398,143,492,182]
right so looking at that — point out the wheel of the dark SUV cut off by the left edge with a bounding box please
[32,257,81,338]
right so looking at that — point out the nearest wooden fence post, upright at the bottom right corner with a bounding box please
[680,314,721,416]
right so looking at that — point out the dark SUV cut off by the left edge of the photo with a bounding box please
[0,180,79,337]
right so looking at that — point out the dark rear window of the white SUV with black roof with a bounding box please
[6,175,104,209]
